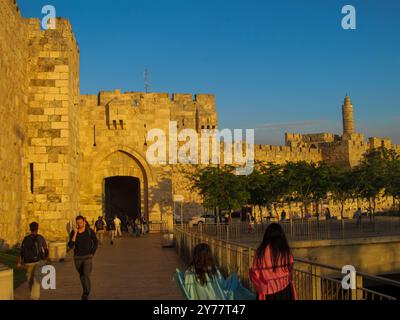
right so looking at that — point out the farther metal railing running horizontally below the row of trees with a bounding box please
[191,217,400,241]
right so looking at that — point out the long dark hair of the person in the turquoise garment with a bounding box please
[189,243,217,285]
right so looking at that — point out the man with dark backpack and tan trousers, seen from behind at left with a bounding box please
[18,222,49,300]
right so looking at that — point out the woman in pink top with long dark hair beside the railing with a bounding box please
[250,223,296,300]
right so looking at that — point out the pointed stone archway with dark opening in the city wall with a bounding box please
[81,146,153,225]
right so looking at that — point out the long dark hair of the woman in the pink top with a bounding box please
[256,223,291,272]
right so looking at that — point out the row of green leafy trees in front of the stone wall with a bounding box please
[188,148,400,220]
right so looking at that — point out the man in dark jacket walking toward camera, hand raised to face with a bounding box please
[68,216,97,300]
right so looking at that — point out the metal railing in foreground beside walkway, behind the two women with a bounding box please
[174,227,400,300]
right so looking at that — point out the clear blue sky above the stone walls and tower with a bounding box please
[19,0,400,144]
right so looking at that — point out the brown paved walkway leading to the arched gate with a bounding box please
[15,234,183,300]
